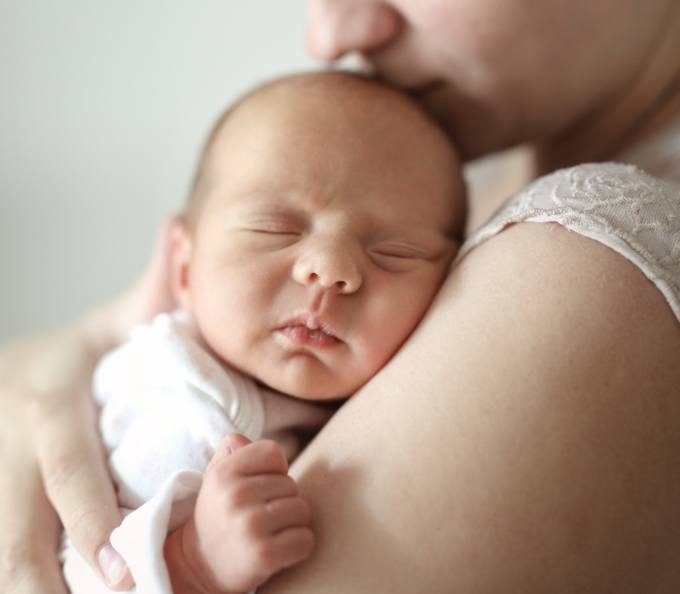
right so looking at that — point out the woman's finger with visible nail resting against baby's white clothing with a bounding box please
[34,399,133,590]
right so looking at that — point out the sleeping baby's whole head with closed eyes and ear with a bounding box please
[173,73,465,400]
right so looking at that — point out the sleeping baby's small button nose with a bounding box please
[293,240,363,295]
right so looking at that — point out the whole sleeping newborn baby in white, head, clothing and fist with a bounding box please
[59,72,465,594]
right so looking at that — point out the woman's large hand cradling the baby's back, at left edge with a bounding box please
[0,219,175,594]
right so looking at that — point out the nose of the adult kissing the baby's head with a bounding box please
[307,0,402,60]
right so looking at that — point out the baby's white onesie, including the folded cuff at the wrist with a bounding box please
[62,312,328,594]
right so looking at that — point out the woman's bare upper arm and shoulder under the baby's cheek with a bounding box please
[261,224,680,594]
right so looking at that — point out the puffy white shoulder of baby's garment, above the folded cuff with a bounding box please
[93,314,264,509]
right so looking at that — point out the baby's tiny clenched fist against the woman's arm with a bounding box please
[168,434,314,594]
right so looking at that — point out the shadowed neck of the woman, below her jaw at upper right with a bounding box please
[533,2,680,175]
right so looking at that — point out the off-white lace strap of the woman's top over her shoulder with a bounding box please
[458,117,680,321]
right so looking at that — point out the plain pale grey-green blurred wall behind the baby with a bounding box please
[0,0,524,342]
